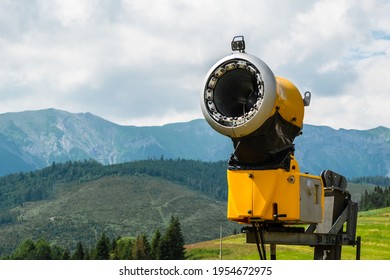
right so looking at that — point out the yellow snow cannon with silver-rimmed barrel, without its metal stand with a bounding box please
[201,36,324,224]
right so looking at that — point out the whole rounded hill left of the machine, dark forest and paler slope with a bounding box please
[0,157,239,255]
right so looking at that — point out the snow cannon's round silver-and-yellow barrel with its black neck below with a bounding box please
[201,52,310,166]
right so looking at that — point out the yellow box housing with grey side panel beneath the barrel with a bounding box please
[227,159,324,224]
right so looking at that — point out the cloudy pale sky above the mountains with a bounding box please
[0,0,390,129]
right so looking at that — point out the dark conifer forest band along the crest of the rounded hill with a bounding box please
[0,158,227,215]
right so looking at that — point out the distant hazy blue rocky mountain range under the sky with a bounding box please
[0,109,390,178]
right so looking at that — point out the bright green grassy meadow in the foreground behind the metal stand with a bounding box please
[187,208,390,260]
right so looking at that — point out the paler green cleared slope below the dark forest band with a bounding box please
[0,175,239,255]
